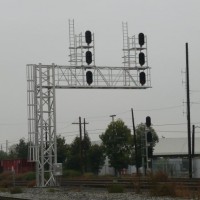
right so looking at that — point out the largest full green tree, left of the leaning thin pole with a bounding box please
[99,119,133,175]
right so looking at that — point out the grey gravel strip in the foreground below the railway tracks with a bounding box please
[0,188,186,200]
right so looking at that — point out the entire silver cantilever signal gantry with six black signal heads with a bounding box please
[27,20,151,187]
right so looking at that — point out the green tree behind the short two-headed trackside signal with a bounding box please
[135,123,159,168]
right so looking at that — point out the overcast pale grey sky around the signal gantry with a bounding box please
[0,0,200,148]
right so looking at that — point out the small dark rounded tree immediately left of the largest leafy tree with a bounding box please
[88,144,105,174]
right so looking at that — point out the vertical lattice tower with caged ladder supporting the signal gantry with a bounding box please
[27,64,57,187]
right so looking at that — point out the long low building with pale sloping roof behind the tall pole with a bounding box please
[152,138,200,178]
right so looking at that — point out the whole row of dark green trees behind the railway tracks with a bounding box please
[0,119,158,174]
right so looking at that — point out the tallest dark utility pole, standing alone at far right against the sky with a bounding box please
[185,43,192,178]
